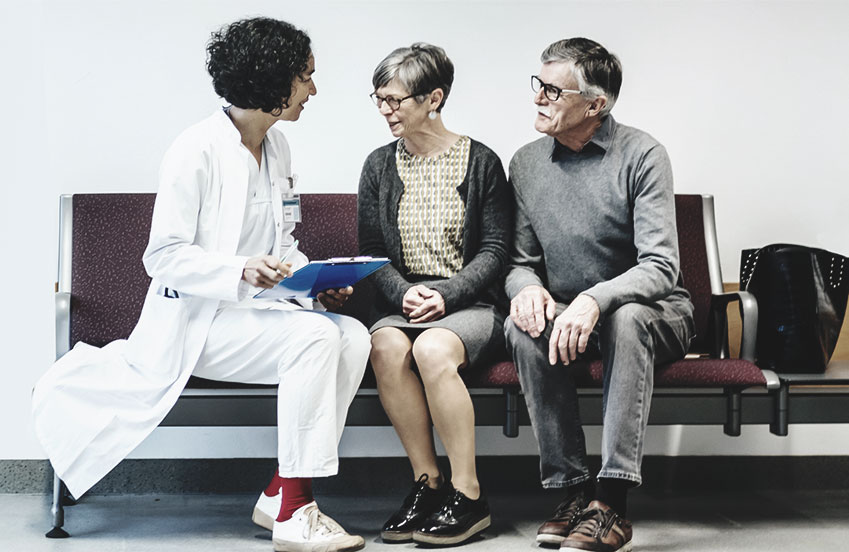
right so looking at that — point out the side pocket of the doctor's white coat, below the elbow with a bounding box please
[124,290,189,386]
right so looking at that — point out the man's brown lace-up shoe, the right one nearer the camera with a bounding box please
[560,500,634,552]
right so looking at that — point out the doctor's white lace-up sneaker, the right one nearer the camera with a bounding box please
[271,501,366,552]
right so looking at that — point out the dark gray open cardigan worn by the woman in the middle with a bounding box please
[357,140,513,313]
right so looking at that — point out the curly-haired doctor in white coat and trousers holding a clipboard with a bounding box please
[33,18,370,550]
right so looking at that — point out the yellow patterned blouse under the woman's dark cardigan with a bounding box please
[395,136,471,278]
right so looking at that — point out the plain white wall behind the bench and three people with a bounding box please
[0,0,849,459]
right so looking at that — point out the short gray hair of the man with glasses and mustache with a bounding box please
[540,38,622,115]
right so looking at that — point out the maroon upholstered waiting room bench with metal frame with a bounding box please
[48,193,808,537]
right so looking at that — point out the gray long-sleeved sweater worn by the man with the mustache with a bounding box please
[506,116,689,315]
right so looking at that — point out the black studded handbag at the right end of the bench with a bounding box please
[740,244,849,373]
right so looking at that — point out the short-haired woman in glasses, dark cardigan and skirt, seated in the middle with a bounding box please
[359,43,511,544]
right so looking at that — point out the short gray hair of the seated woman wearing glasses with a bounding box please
[371,42,454,111]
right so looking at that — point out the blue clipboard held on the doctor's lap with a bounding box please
[254,257,389,299]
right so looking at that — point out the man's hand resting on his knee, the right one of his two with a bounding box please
[548,294,600,366]
